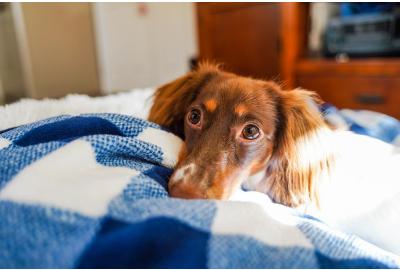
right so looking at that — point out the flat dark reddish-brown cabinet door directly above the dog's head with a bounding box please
[197,3,280,79]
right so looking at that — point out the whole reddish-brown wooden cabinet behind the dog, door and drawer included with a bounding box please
[197,3,400,119]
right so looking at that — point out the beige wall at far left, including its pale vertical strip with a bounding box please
[0,2,99,102]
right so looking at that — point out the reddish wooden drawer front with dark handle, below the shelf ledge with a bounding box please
[298,75,400,118]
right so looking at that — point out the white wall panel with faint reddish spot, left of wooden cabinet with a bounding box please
[93,3,197,93]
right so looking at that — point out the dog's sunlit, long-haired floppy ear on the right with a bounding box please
[265,89,333,206]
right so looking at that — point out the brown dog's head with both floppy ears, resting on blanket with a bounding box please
[149,65,330,206]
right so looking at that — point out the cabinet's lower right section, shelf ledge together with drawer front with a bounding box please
[296,59,400,119]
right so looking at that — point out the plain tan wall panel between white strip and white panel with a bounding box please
[17,3,99,98]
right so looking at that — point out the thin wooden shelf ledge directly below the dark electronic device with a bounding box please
[295,58,400,77]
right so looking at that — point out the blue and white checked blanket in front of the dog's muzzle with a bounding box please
[0,114,400,268]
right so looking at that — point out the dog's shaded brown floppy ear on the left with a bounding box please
[148,63,220,138]
